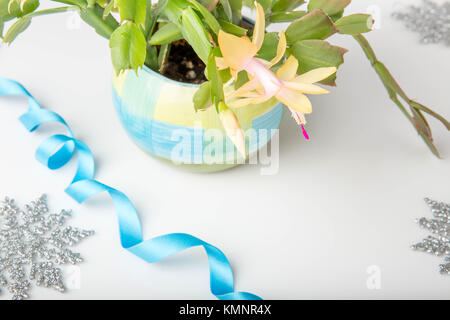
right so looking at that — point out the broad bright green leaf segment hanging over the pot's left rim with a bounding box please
[109,21,146,73]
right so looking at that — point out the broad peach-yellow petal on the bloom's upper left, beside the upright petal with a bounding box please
[219,30,258,71]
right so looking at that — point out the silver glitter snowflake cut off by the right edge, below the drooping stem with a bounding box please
[411,198,450,275]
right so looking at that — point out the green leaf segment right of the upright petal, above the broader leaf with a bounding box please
[286,10,337,45]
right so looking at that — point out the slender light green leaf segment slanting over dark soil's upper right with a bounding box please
[181,7,212,63]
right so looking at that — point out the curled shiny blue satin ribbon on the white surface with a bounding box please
[0,78,261,300]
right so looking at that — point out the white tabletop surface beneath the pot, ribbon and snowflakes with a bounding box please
[0,0,450,299]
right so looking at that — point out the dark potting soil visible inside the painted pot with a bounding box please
[162,40,206,83]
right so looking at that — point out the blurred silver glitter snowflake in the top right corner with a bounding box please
[392,0,450,46]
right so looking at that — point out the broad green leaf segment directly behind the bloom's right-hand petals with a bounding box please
[291,40,347,86]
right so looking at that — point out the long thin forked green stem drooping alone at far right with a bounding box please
[353,34,450,158]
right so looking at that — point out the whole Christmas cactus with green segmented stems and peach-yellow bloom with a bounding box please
[0,0,450,156]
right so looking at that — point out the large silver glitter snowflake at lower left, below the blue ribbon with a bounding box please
[0,195,94,300]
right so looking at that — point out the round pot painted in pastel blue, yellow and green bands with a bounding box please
[113,66,283,172]
